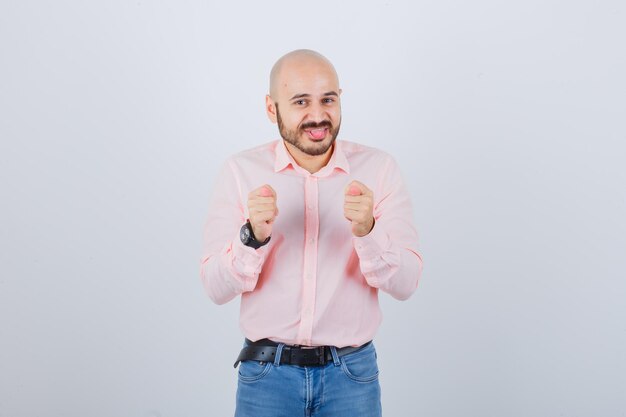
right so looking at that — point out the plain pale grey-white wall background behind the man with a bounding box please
[0,0,626,417]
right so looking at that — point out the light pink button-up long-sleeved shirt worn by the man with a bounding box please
[201,140,422,347]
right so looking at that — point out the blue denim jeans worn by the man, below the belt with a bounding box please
[235,343,382,417]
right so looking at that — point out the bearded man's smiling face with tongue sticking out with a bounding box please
[274,58,341,156]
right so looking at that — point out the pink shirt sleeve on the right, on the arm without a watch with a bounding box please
[353,156,422,300]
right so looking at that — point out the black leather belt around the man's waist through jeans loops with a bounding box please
[234,339,372,368]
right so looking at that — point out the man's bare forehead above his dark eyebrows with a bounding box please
[278,60,339,99]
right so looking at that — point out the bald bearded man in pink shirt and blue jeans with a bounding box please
[201,50,422,417]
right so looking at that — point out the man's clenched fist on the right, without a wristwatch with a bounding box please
[343,181,374,237]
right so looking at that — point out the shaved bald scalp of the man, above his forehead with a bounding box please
[270,49,339,101]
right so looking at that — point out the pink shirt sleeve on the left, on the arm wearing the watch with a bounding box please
[200,160,267,304]
